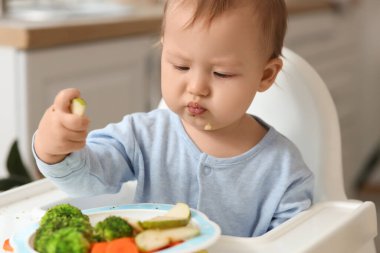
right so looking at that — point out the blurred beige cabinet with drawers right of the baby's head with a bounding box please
[285,6,367,196]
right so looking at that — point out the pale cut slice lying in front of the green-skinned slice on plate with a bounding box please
[135,227,200,252]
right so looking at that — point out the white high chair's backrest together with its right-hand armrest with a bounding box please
[159,48,377,253]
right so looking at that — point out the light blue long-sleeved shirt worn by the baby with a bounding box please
[35,110,313,237]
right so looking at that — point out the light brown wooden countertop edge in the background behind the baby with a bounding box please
[0,0,354,50]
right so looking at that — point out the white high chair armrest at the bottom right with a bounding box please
[209,200,377,253]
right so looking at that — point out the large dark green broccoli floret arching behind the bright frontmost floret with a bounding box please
[34,204,93,253]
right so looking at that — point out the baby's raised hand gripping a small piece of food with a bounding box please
[34,88,89,164]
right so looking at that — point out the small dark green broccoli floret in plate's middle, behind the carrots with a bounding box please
[94,216,133,241]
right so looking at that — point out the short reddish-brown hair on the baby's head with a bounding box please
[161,0,288,59]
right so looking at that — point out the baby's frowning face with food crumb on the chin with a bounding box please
[161,1,278,131]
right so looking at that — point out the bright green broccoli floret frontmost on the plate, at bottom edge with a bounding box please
[44,228,90,253]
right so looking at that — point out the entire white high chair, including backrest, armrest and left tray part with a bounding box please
[0,49,377,253]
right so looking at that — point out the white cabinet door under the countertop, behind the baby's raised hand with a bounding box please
[18,36,156,177]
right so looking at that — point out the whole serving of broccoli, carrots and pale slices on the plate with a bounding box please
[33,203,200,253]
